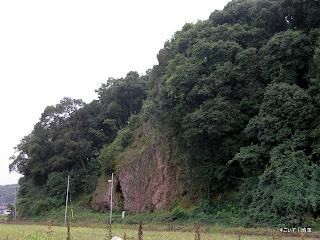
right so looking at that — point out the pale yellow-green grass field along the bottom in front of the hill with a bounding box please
[0,224,315,240]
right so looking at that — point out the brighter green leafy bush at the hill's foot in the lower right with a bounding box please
[249,149,320,227]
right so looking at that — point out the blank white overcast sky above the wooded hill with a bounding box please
[0,0,230,185]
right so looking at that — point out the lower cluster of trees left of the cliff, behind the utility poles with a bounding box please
[10,72,148,215]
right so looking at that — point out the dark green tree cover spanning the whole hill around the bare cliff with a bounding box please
[10,0,320,225]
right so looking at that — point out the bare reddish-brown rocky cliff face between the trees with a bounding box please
[92,123,185,212]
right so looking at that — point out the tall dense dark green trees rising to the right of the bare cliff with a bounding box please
[144,0,320,224]
